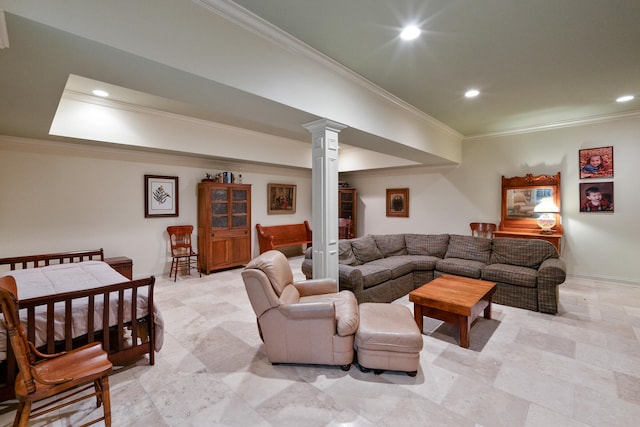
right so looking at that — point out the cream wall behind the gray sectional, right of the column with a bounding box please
[340,115,640,285]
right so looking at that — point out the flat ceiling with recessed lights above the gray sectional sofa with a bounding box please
[235,0,640,136]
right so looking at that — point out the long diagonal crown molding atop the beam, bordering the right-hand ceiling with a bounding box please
[192,0,463,138]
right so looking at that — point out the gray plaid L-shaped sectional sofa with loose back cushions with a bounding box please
[302,234,566,314]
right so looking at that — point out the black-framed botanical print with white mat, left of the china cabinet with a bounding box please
[144,175,179,218]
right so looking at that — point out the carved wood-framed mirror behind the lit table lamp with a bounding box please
[500,172,562,233]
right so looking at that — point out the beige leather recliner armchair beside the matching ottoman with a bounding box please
[242,250,358,371]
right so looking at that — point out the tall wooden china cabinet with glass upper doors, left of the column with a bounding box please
[198,182,251,274]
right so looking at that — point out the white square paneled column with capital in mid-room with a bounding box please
[303,119,346,281]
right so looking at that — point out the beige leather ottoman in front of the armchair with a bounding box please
[354,302,422,377]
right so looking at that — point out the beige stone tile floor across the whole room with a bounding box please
[0,257,640,427]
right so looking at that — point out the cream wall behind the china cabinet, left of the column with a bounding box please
[0,137,311,277]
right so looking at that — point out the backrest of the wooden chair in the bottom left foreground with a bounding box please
[0,276,36,393]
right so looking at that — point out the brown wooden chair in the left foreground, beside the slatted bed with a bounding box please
[0,276,113,427]
